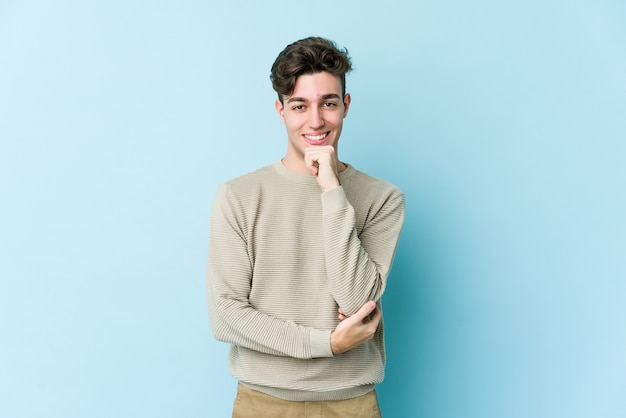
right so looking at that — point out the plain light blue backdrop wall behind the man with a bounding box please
[0,0,626,418]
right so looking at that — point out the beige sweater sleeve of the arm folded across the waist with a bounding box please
[207,185,333,359]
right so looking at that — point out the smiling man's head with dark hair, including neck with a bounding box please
[271,38,351,174]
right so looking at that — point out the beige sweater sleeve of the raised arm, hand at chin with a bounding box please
[322,186,404,316]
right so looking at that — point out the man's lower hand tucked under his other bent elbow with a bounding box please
[330,301,383,355]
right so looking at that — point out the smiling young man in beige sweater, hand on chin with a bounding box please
[207,38,404,418]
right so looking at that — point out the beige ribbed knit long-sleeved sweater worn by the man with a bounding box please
[207,161,404,401]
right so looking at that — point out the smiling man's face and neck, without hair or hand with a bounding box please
[276,72,350,173]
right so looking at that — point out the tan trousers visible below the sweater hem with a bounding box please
[233,384,382,418]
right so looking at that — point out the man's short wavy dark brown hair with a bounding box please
[270,37,352,102]
